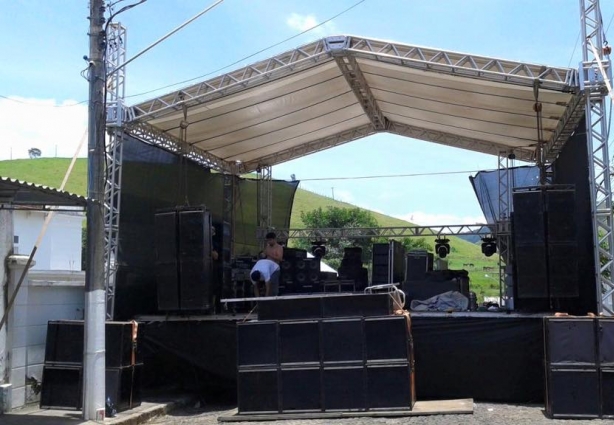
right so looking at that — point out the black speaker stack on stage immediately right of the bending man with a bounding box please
[279,248,321,295]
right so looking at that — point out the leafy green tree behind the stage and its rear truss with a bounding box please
[296,207,379,269]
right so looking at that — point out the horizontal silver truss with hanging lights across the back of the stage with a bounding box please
[258,223,509,240]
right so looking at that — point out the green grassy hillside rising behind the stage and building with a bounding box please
[0,158,499,296]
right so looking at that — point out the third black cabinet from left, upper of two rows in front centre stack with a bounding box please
[321,318,364,365]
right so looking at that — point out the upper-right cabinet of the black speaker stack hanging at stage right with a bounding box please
[544,190,576,243]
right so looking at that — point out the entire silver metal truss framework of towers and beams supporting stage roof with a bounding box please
[104,0,614,319]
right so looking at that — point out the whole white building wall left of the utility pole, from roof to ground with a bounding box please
[0,210,85,409]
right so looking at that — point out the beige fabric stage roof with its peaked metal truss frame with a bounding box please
[127,36,584,173]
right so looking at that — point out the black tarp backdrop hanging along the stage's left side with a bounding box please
[115,138,298,320]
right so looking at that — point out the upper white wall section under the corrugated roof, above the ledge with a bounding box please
[13,210,84,271]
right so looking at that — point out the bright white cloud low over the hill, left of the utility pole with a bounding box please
[0,97,87,160]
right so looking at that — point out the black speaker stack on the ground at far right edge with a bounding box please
[544,317,614,419]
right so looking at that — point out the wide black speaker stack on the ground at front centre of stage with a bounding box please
[237,295,415,415]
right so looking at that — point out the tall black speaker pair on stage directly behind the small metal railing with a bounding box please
[371,239,406,285]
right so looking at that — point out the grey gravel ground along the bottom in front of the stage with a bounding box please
[148,403,614,425]
